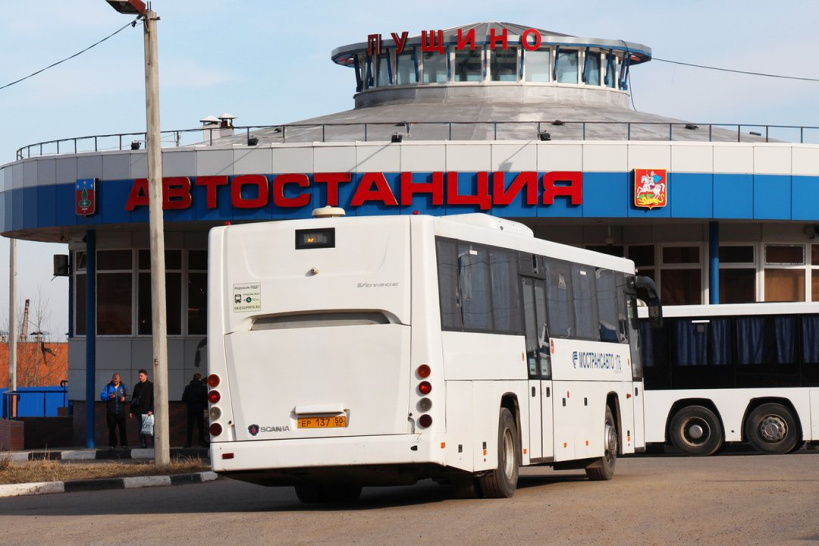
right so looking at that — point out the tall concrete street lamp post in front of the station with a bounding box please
[106,0,171,469]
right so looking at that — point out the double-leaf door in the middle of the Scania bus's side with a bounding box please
[521,277,553,461]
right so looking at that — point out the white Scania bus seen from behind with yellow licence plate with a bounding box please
[208,209,660,502]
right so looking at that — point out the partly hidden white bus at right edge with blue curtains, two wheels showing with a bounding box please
[641,303,819,455]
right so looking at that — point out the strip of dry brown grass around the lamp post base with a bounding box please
[0,454,210,484]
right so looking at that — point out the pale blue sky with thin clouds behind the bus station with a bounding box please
[0,0,819,337]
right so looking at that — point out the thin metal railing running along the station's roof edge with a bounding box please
[17,120,819,160]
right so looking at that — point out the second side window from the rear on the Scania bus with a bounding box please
[458,243,492,330]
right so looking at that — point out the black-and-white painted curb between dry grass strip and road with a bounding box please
[0,468,219,498]
